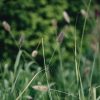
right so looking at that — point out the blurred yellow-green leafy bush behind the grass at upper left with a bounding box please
[0,0,82,58]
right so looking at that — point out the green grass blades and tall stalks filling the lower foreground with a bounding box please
[0,0,100,100]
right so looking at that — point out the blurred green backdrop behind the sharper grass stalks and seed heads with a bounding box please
[0,0,100,100]
